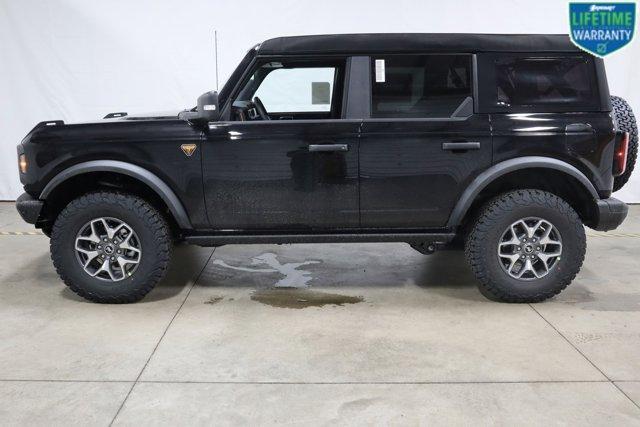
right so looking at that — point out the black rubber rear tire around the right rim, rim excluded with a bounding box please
[465,190,586,303]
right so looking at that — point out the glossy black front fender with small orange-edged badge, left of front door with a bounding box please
[21,119,208,227]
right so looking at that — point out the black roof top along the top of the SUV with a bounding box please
[258,33,580,55]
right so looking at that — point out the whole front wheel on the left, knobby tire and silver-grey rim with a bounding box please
[50,191,171,303]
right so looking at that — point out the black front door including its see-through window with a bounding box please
[203,59,361,231]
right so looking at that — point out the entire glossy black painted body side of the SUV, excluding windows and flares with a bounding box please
[19,40,615,233]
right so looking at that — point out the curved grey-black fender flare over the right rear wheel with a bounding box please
[447,156,600,228]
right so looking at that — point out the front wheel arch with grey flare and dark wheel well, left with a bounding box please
[39,160,193,234]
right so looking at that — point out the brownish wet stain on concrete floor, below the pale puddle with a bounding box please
[251,288,364,309]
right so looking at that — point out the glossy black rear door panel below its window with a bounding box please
[360,114,492,228]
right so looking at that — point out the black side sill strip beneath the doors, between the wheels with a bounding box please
[185,233,455,246]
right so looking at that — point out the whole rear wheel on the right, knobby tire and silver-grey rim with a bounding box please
[465,190,586,303]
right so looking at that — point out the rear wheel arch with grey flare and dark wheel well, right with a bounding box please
[447,156,600,228]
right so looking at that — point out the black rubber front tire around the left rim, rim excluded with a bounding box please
[50,191,171,304]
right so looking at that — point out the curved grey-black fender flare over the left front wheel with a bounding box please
[39,160,193,229]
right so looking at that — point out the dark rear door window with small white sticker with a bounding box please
[371,55,472,118]
